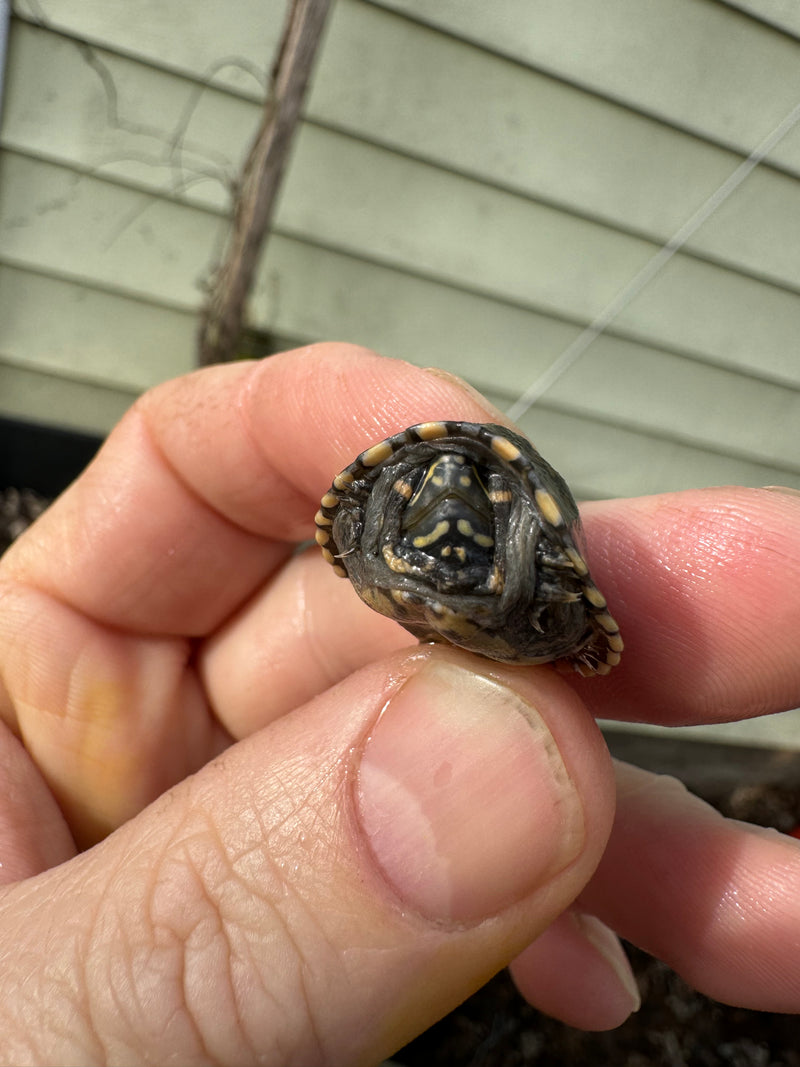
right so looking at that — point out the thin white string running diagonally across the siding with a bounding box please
[507,96,800,419]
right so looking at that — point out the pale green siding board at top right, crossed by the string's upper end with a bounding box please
[375,0,800,168]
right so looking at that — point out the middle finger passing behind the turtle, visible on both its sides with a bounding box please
[203,488,800,736]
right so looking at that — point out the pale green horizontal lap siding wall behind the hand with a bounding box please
[0,0,800,495]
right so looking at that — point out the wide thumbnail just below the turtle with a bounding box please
[358,660,585,922]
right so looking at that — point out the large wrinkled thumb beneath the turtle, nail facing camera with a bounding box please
[0,648,613,1067]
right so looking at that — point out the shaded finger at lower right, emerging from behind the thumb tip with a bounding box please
[580,764,800,1013]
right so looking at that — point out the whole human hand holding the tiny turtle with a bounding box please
[0,346,800,1065]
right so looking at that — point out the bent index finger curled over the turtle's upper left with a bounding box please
[3,345,499,636]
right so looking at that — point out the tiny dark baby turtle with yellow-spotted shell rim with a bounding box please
[316,421,623,675]
